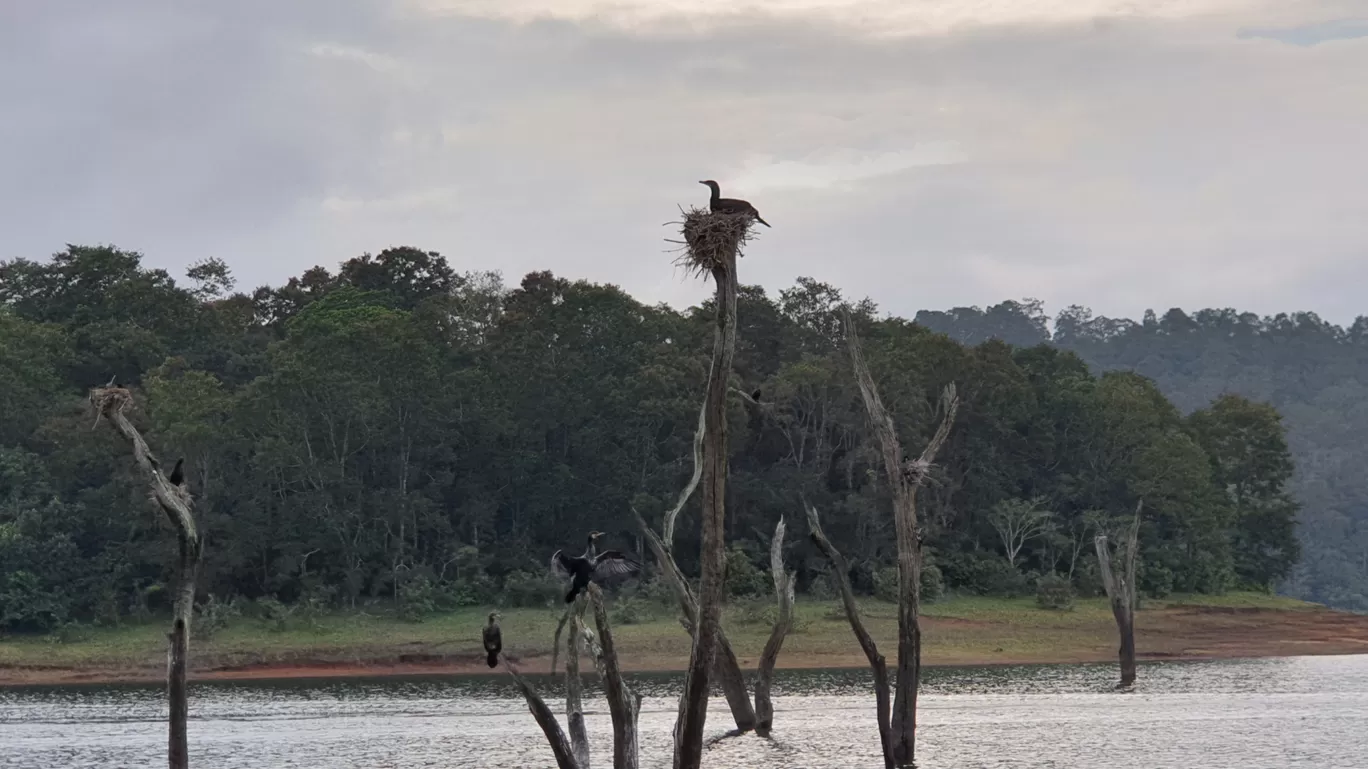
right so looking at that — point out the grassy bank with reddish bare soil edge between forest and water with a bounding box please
[0,594,1368,684]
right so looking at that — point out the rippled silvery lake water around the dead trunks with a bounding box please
[0,655,1368,769]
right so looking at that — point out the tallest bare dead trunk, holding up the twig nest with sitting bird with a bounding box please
[674,239,748,769]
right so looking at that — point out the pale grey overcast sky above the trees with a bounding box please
[0,0,1368,323]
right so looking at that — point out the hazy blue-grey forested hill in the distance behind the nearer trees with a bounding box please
[915,300,1368,612]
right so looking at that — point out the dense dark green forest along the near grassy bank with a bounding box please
[0,246,1298,631]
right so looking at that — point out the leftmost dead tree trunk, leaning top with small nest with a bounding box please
[90,387,201,769]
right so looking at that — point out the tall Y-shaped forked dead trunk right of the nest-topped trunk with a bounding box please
[845,311,959,766]
